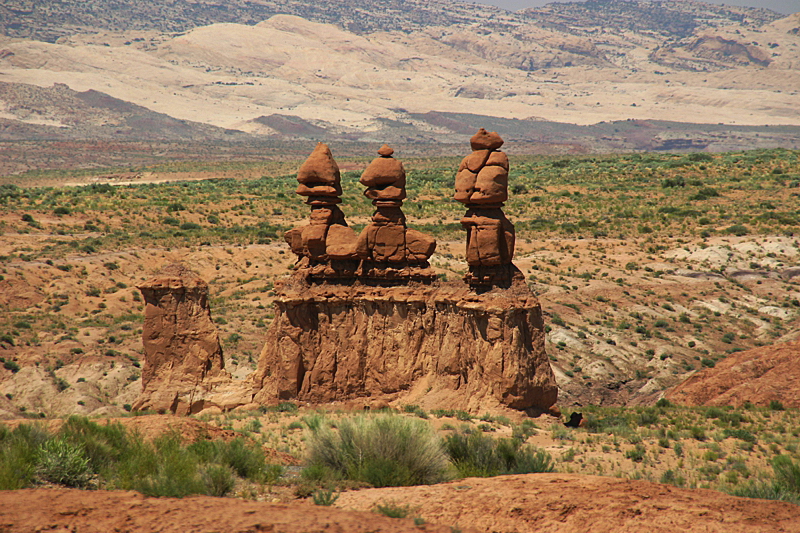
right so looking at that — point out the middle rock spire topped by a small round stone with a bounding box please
[356,144,436,281]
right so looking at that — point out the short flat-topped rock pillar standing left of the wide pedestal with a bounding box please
[133,264,229,414]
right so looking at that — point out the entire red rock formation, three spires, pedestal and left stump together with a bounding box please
[131,137,558,413]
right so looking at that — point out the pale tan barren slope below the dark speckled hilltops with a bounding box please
[0,2,800,140]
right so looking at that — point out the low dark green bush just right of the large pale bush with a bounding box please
[445,431,553,477]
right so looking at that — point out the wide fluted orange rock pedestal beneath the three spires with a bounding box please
[249,283,557,411]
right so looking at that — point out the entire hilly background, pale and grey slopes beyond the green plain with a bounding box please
[0,0,800,151]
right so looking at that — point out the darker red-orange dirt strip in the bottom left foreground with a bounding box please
[0,489,474,533]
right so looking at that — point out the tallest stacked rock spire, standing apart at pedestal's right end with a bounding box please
[453,128,522,286]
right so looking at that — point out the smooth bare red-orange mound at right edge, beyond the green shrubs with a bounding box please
[666,341,800,408]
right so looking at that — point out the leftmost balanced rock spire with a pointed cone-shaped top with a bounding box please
[284,143,359,280]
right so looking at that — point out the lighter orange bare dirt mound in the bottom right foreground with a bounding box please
[336,474,800,533]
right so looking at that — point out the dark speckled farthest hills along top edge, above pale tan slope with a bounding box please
[0,0,781,42]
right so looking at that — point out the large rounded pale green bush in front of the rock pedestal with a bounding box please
[306,415,448,487]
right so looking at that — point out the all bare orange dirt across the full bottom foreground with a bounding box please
[0,474,800,533]
